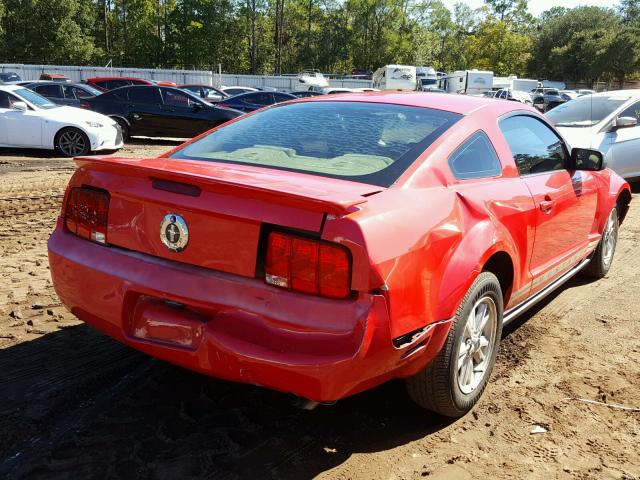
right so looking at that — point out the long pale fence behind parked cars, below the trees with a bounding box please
[0,64,372,90]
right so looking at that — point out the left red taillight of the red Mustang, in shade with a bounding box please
[64,187,109,243]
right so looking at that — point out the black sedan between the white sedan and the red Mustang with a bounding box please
[86,85,242,139]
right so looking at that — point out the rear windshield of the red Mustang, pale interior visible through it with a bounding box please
[171,101,461,187]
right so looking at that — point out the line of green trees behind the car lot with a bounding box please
[0,0,640,83]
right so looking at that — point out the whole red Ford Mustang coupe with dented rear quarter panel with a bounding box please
[49,93,631,417]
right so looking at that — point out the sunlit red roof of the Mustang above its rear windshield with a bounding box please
[299,91,523,115]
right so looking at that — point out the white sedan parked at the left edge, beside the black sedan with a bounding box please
[0,85,123,157]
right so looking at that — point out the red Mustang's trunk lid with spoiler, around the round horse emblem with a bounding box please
[74,157,381,277]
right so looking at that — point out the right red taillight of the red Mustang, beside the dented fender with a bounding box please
[265,232,351,298]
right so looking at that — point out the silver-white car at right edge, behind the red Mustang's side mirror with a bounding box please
[546,90,640,179]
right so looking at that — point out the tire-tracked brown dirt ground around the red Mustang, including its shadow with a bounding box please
[0,141,640,480]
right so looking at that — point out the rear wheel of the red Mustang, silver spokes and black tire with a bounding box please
[407,272,503,417]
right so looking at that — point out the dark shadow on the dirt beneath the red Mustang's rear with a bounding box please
[0,325,452,479]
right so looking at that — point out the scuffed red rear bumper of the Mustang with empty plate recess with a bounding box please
[49,223,450,401]
